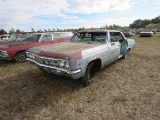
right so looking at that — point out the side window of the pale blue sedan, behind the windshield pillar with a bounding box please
[110,32,124,42]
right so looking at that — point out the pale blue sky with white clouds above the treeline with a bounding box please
[0,0,160,31]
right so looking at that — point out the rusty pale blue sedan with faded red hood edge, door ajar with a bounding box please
[26,30,135,86]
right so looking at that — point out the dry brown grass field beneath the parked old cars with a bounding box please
[0,33,160,120]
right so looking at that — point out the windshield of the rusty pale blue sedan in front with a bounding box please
[71,32,106,44]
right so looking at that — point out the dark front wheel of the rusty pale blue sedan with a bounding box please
[81,62,95,86]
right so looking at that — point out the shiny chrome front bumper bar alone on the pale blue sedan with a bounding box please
[26,58,81,75]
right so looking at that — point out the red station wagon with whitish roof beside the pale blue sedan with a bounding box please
[0,33,69,62]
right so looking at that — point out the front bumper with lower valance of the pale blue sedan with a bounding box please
[26,58,81,79]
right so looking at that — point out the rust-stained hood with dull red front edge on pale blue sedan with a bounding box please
[28,42,99,59]
